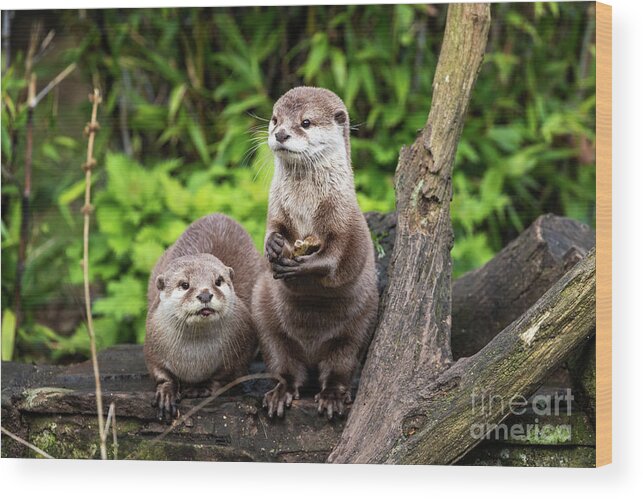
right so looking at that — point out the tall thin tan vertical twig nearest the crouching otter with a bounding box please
[82,88,107,459]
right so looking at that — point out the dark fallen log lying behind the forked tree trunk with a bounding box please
[366,212,596,359]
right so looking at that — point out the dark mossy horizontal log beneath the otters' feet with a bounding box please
[2,345,342,462]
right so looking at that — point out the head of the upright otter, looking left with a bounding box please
[268,87,350,166]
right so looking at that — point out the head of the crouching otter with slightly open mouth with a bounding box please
[156,253,236,326]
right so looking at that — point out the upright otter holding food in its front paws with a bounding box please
[252,87,378,419]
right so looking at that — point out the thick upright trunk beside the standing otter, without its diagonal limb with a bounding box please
[329,4,490,463]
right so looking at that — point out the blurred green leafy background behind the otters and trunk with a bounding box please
[1,3,595,362]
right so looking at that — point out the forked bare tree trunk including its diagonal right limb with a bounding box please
[328,4,595,464]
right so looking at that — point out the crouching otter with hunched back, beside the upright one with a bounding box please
[144,214,262,418]
